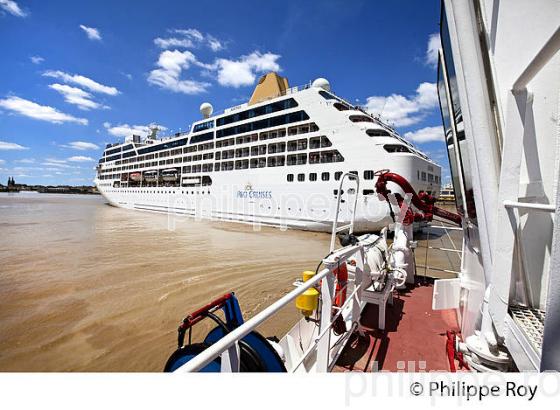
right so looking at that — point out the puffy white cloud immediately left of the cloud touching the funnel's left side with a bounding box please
[148,50,210,94]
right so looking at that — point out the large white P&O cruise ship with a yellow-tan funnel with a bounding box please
[95,72,441,232]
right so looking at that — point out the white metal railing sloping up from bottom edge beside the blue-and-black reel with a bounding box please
[177,244,365,372]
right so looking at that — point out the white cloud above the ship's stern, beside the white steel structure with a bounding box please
[365,83,438,127]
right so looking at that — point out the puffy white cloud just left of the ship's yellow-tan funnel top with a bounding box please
[215,51,280,88]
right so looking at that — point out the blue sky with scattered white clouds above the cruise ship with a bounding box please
[0,0,449,185]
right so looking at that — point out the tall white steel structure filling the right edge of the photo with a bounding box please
[434,0,560,370]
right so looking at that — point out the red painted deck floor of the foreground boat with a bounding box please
[334,279,459,372]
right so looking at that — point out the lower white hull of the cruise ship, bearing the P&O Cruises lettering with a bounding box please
[96,157,428,232]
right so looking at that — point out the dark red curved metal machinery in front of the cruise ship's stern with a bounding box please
[375,170,462,226]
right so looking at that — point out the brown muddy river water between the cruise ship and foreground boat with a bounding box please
[0,193,460,372]
